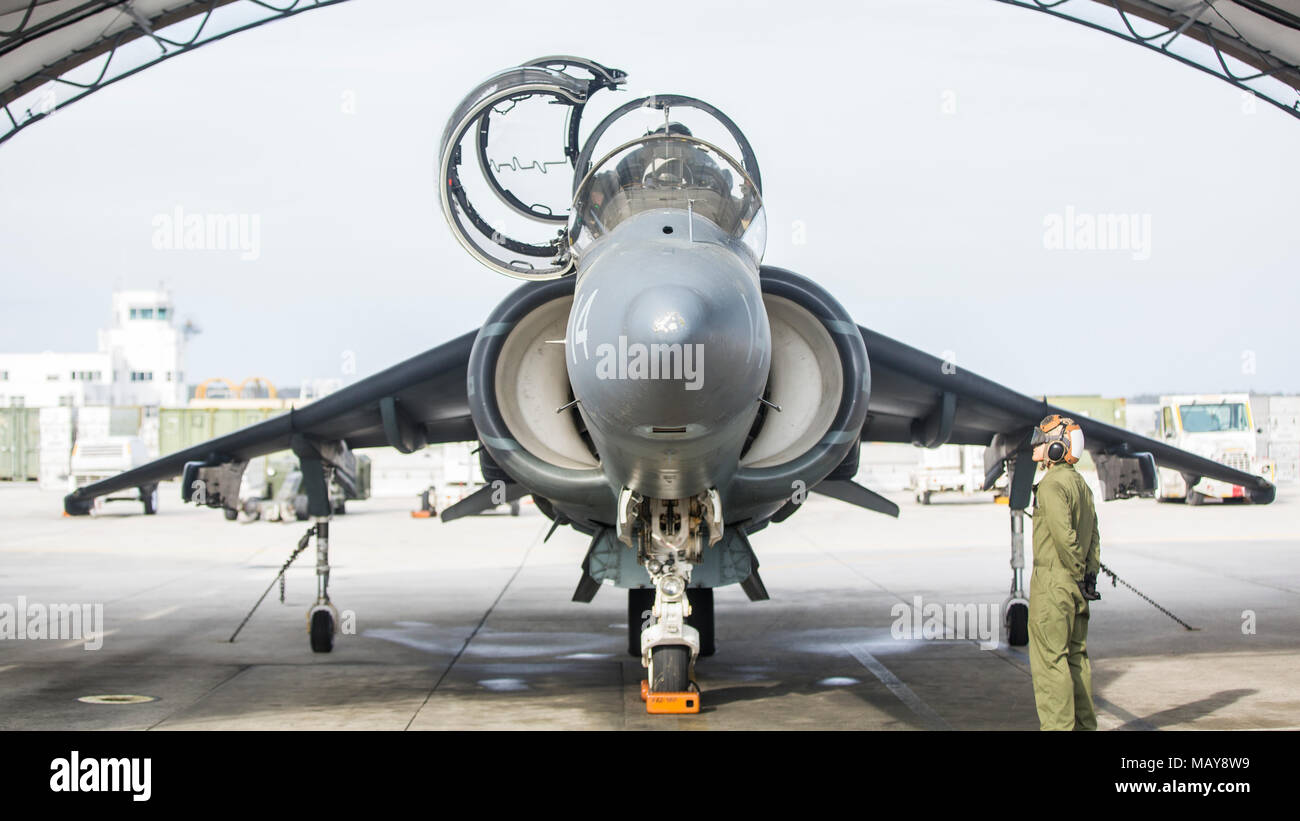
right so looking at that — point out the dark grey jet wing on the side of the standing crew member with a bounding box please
[858,326,1275,507]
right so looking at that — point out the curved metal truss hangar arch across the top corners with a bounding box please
[0,0,1300,143]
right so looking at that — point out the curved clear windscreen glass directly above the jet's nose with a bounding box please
[568,134,767,262]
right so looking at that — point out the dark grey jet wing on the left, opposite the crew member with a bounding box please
[64,331,478,514]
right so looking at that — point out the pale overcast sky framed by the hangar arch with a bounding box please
[0,0,1300,395]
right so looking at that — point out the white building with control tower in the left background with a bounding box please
[0,291,187,408]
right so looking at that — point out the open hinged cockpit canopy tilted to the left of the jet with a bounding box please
[438,57,625,279]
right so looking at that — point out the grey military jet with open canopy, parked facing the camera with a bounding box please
[64,57,1274,692]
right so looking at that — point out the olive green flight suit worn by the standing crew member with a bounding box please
[1030,462,1101,730]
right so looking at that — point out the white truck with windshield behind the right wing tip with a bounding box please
[1156,394,1277,504]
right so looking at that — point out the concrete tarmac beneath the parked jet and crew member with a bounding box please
[0,483,1300,730]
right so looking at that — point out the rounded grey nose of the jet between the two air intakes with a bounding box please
[567,229,772,499]
